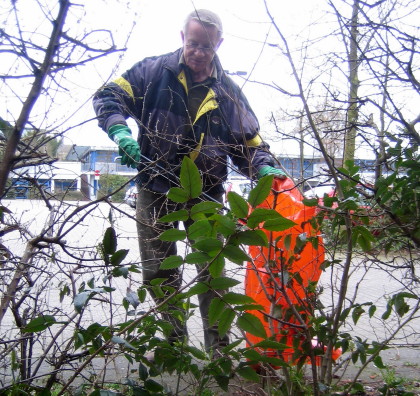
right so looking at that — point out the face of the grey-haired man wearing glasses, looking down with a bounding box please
[181,20,223,73]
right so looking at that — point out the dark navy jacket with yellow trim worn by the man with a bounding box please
[93,49,273,193]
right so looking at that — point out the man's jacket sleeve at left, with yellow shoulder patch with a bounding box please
[93,64,141,132]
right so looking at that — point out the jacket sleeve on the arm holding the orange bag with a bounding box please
[223,77,274,178]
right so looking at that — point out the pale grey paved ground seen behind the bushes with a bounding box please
[0,200,420,392]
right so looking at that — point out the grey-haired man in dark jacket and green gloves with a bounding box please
[94,10,285,352]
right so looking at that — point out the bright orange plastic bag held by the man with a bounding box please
[245,178,338,364]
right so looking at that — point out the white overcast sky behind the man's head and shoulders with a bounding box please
[63,0,328,151]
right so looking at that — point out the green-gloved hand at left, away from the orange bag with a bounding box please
[108,124,140,168]
